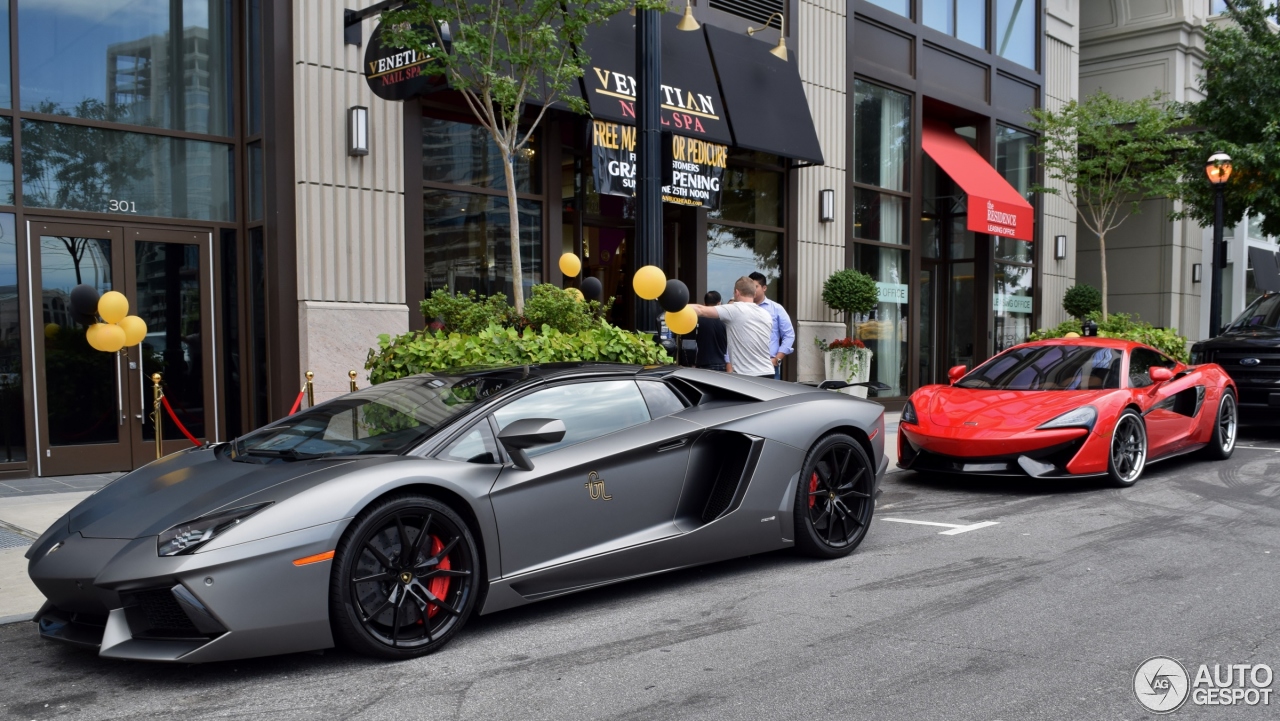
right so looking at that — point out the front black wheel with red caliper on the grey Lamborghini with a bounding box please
[329,496,480,658]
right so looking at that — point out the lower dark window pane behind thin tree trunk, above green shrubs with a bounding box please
[422,188,543,301]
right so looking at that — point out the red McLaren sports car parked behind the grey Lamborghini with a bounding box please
[897,338,1238,485]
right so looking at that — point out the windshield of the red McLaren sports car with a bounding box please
[956,346,1120,391]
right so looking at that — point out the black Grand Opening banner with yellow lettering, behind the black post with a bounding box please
[591,120,728,210]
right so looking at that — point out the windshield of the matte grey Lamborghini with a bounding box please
[232,375,515,461]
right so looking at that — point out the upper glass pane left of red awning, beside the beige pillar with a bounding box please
[854,81,911,191]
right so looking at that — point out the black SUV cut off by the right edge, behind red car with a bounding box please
[1192,293,1280,420]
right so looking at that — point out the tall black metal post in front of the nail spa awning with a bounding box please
[635,10,662,333]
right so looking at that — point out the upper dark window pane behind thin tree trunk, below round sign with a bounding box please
[422,118,543,193]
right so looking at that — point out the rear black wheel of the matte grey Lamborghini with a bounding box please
[795,433,876,558]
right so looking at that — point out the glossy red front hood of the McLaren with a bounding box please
[916,385,1110,430]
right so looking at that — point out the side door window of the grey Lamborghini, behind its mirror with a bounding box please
[493,380,649,456]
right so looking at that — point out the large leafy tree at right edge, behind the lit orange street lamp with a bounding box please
[1179,0,1280,236]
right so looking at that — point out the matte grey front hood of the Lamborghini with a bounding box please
[68,447,356,539]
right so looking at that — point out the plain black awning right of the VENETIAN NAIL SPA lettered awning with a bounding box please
[706,24,823,165]
